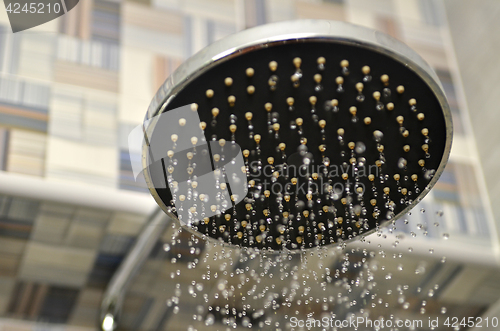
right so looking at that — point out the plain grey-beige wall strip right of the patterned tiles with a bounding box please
[444,0,500,243]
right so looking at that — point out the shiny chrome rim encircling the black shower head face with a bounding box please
[142,20,453,252]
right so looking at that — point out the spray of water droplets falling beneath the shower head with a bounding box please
[159,208,450,331]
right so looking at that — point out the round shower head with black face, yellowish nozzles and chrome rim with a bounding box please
[143,20,452,250]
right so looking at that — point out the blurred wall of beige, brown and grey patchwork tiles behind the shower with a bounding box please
[0,0,500,330]
